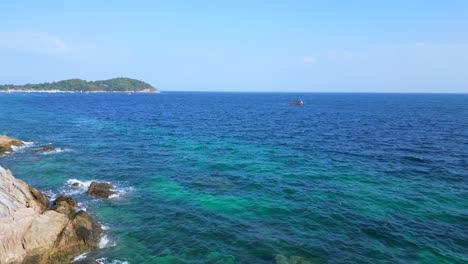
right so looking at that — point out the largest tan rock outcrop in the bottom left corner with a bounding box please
[0,167,102,264]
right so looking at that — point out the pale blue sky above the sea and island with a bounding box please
[0,0,468,93]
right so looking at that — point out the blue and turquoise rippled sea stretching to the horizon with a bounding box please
[0,93,468,263]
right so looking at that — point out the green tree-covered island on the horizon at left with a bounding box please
[0,77,159,93]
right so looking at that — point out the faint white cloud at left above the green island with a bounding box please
[0,32,70,55]
